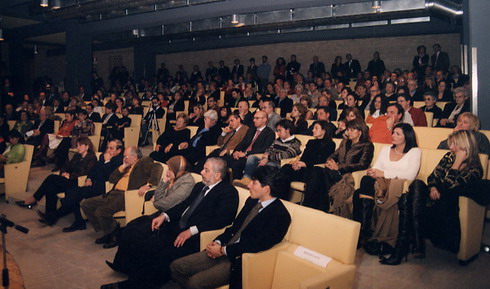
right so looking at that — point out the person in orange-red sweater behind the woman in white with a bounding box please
[369,103,405,144]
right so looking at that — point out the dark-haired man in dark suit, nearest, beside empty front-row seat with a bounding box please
[170,166,291,289]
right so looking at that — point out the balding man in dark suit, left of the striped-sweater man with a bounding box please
[225,111,275,179]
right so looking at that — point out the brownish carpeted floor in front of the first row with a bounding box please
[0,158,490,289]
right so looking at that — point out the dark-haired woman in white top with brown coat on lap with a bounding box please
[353,123,421,255]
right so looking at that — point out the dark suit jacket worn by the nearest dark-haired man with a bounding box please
[216,197,291,262]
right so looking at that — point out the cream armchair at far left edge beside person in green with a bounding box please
[0,144,34,202]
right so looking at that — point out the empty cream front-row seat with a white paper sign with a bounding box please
[201,188,360,289]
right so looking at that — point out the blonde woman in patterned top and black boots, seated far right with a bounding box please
[380,130,483,265]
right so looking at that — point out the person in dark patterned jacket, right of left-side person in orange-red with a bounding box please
[52,110,95,172]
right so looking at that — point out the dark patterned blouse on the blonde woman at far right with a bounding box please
[427,152,483,192]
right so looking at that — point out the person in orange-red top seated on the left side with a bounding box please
[33,110,79,166]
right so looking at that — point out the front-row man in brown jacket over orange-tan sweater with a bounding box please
[81,147,163,249]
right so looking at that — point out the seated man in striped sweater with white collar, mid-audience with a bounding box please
[233,119,301,187]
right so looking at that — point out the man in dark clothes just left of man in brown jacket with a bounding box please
[60,139,124,233]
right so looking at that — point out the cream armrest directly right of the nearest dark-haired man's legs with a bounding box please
[242,242,289,289]
